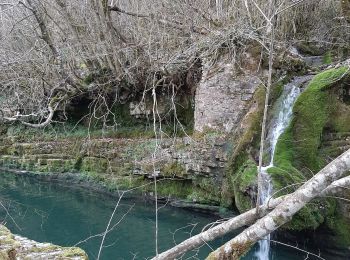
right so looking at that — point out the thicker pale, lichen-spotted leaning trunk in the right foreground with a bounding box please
[207,149,350,260]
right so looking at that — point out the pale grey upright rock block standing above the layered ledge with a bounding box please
[195,56,260,133]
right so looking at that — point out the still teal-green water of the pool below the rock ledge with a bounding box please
[0,173,334,260]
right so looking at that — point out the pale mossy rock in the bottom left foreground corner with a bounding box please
[0,225,88,260]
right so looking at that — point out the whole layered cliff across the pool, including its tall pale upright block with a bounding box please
[0,53,259,207]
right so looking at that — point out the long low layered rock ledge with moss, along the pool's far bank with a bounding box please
[0,135,230,205]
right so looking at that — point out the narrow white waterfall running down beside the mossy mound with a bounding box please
[255,76,310,260]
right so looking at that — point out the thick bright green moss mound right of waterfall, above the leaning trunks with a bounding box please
[274,67,347,172]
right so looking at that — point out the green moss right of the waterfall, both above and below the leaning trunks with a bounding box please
[268,67,350,230]
